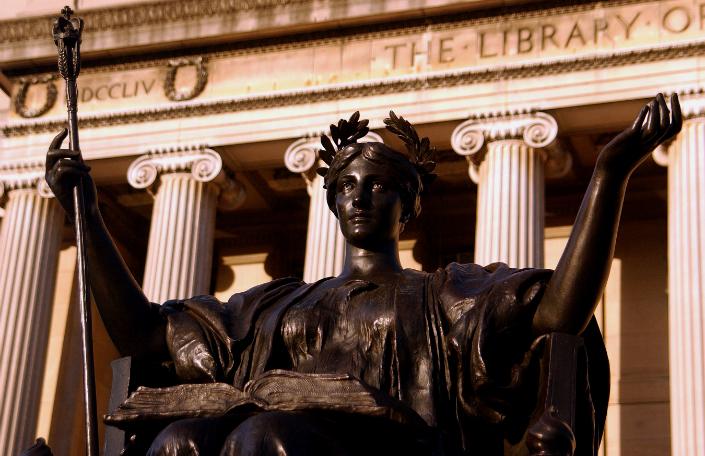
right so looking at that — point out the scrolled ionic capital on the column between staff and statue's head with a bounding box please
[127,145,245,210]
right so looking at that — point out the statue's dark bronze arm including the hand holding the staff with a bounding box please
[46,130,169,360]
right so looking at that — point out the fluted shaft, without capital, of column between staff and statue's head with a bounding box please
[143,173,218,303]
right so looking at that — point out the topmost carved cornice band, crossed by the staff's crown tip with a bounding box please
[0,0,300,43]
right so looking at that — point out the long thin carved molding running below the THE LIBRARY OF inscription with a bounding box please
[2,42,705,137]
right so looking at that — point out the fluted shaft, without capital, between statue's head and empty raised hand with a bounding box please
[475,139,544,268]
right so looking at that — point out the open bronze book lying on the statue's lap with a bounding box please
[105,370,425,428]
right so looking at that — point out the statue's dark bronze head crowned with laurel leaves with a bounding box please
[319,112,435,239]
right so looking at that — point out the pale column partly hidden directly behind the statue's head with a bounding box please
[284,132,384,283]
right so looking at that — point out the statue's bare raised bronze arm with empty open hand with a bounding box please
[533,94,682,335]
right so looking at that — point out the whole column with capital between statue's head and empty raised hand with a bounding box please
[451,112,571,268]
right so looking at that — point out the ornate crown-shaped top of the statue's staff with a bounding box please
[52,6,83,80]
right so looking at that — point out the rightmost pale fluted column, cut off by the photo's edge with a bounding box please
[654,94,705,456]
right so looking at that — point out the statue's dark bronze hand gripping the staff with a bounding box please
[45,129,96,218]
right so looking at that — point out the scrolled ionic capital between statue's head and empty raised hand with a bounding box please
[451,112,572,183]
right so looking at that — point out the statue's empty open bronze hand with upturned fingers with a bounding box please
[596,93,683,179]
